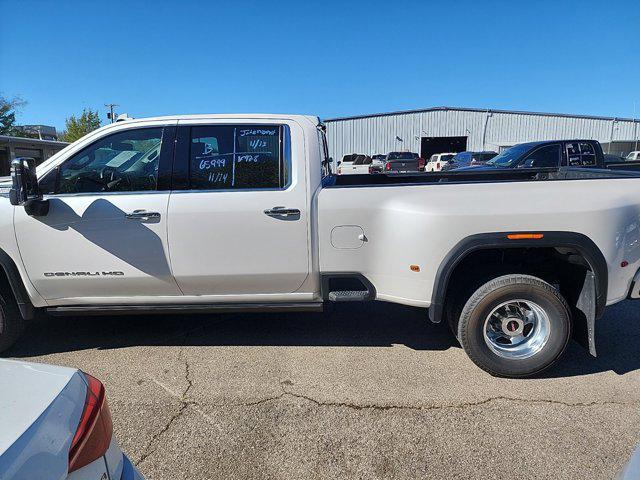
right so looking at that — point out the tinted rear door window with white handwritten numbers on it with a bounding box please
[189,125,288,190]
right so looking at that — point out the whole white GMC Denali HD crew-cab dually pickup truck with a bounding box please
[0,115,640,377]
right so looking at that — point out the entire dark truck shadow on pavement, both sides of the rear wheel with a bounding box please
[3,302,640,378]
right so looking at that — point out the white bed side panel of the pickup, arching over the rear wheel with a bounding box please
[318,177,640,307]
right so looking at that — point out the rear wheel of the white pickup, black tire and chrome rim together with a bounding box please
[458,275,571,378]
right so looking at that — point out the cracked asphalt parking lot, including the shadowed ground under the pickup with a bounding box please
[9,302,640,480]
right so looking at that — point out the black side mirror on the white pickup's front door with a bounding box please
[9,157,49,216]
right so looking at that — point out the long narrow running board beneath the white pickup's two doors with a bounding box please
[47,302,322,316]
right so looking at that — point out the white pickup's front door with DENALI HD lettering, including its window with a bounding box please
[14,122,180,304]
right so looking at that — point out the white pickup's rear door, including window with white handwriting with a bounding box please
[168,121,309,296]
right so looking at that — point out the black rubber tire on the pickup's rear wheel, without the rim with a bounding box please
[457,274,571,378]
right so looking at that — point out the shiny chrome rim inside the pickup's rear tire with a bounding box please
[483,299,551,359]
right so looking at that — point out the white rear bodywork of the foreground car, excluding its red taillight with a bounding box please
[0,360,87,478]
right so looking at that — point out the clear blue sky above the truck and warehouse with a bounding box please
[0,0,640,128]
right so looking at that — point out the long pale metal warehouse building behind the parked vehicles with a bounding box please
[325,107,640,160]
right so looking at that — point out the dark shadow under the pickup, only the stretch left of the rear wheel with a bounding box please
[6,302,457,357]
